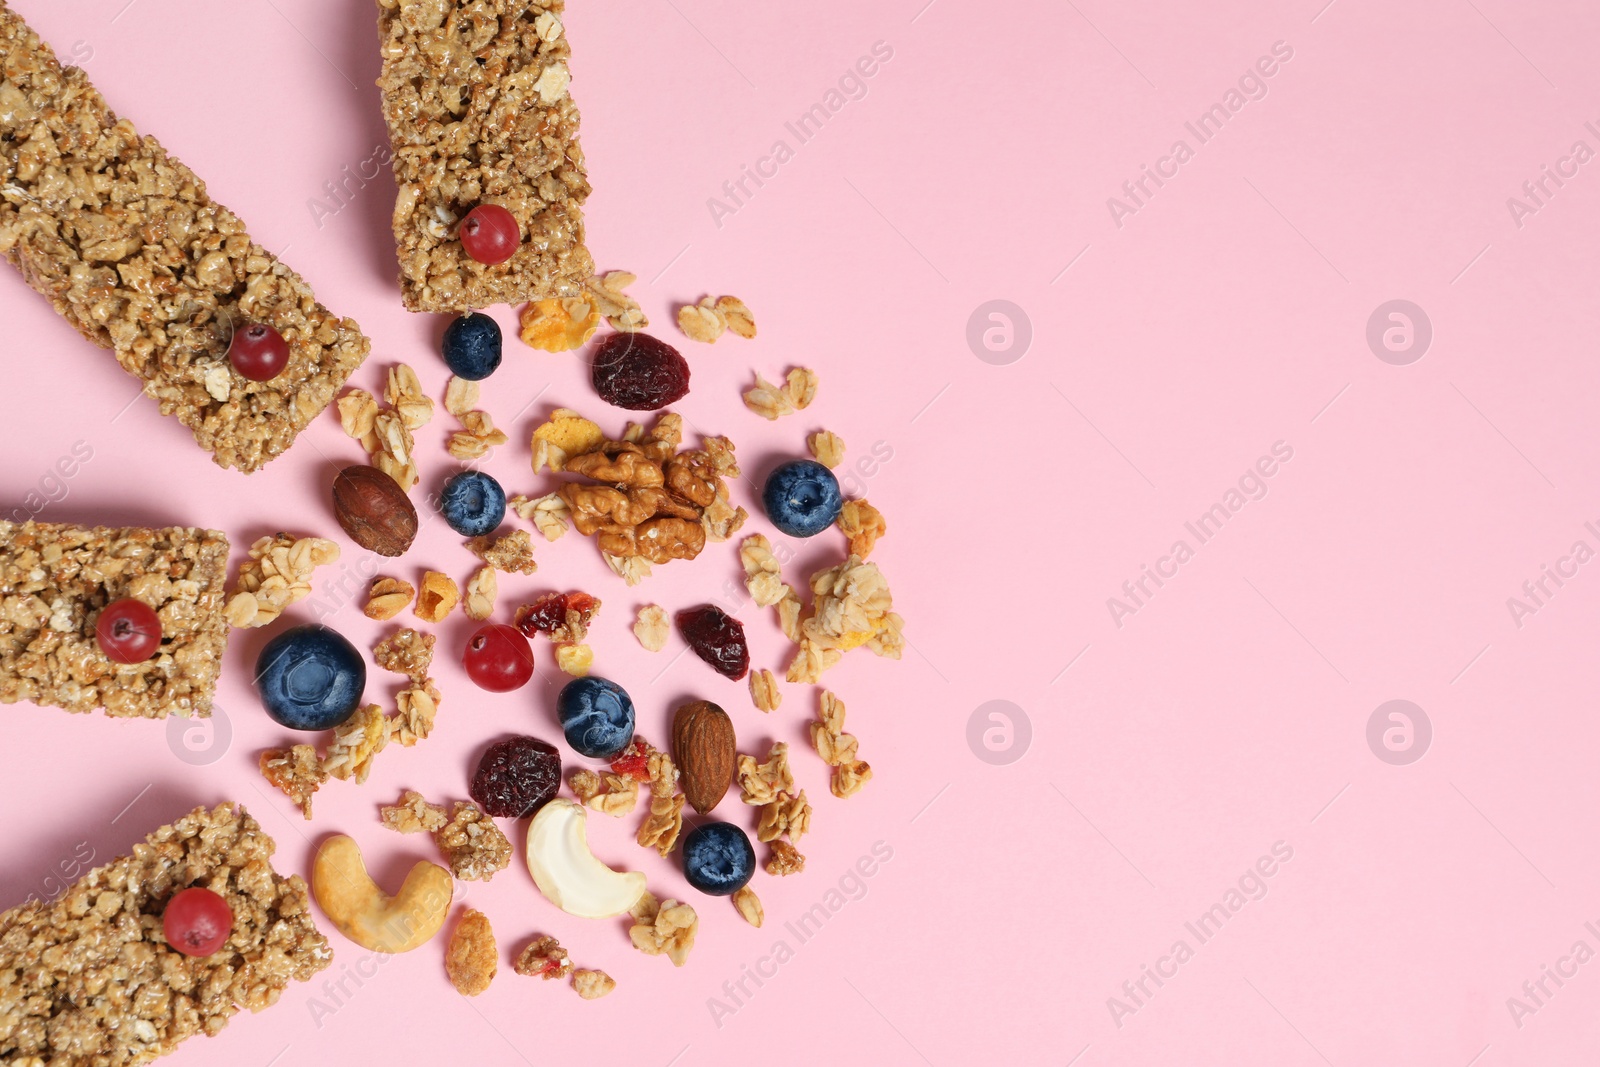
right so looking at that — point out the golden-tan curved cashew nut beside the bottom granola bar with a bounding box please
[310,833,454,953]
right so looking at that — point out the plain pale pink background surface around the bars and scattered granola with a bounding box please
[0,0,1600,1067]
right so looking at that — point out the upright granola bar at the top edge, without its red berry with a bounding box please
[378,0,594,312]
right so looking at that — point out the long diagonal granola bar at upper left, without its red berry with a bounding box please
[0,0,370,472]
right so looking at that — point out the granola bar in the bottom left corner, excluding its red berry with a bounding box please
[0,805,333,1067]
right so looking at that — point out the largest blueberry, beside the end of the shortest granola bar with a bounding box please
[256,624,366,729]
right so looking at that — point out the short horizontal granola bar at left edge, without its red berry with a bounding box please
[0,522,227,716]
